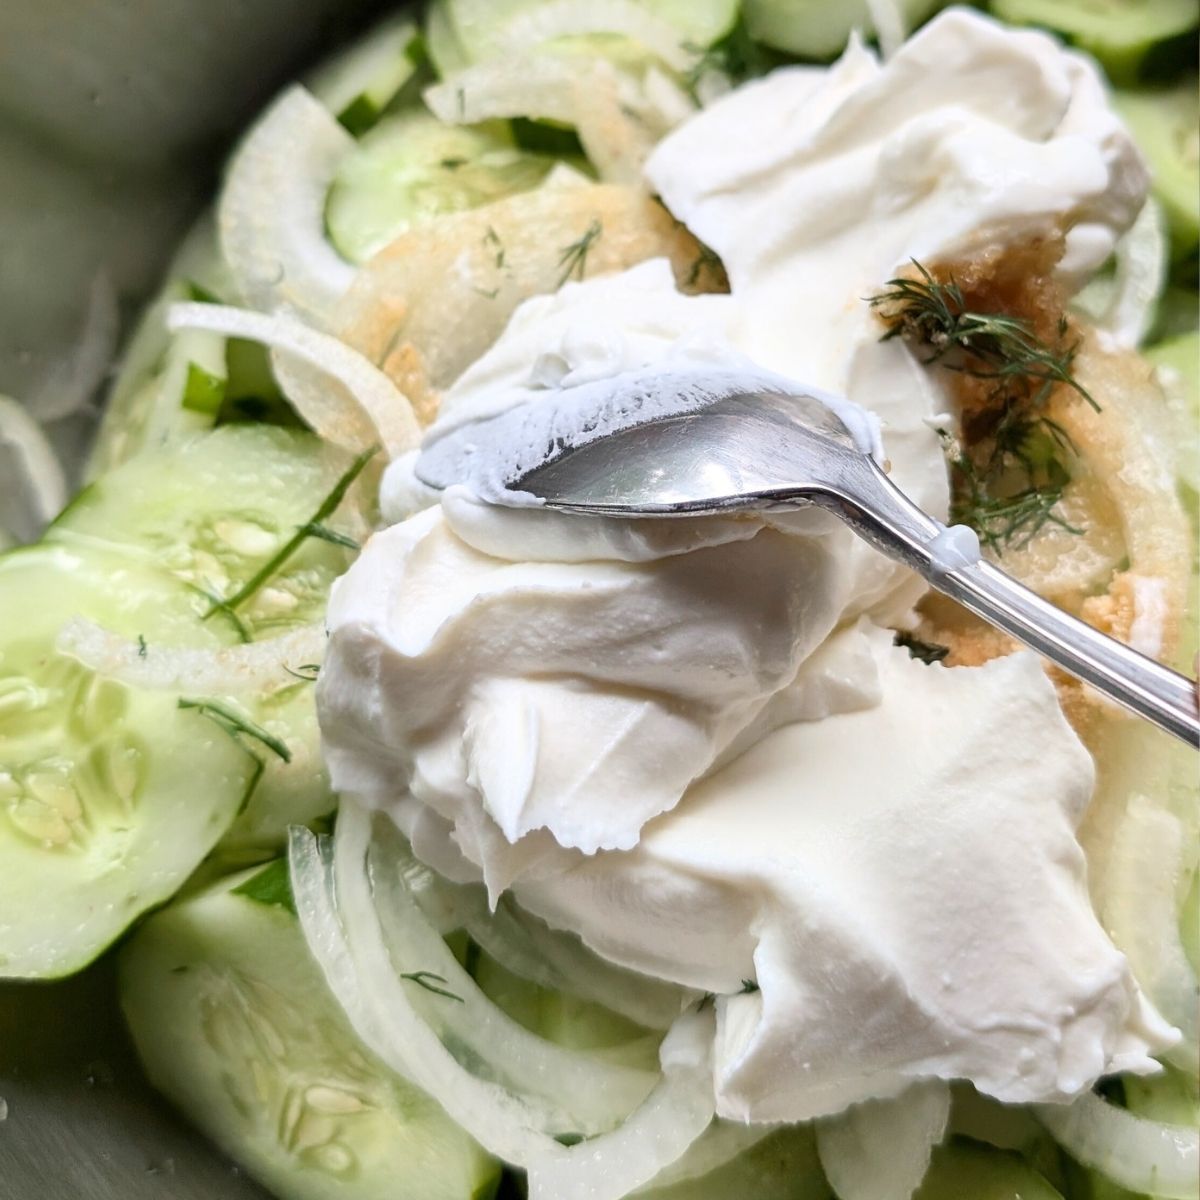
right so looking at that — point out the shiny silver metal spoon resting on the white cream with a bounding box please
[510,394,1200,746]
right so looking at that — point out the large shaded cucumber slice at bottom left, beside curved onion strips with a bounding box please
[120,868,499,1200]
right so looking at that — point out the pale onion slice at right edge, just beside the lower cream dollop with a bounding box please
[1104,794,1200,1073]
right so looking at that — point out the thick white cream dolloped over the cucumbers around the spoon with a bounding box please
[318,12,1172,1121]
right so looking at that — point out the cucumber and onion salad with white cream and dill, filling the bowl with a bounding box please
[0,0,1200,1200]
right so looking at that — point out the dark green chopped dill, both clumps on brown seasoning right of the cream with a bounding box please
[868,260,1099,554]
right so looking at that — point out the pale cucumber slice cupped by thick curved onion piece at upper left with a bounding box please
[325,109,554,263]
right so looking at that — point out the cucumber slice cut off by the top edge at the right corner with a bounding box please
[990,0,1200,79]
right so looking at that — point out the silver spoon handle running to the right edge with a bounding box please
[810,460,1200,749]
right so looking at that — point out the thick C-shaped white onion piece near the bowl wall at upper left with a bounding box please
[217,85,354,323]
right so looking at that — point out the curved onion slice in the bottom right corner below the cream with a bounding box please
[1036,1092,1200,1200]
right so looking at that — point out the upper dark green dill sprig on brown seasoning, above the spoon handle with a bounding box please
[868,259,1099,412]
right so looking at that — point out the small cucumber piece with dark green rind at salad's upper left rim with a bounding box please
[308,18,422,137]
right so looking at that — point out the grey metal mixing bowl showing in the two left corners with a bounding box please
[0,0,395,1200]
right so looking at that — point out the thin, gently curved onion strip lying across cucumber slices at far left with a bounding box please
[56,617,325,692]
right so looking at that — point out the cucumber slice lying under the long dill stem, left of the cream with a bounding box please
[47,425,362,640]
